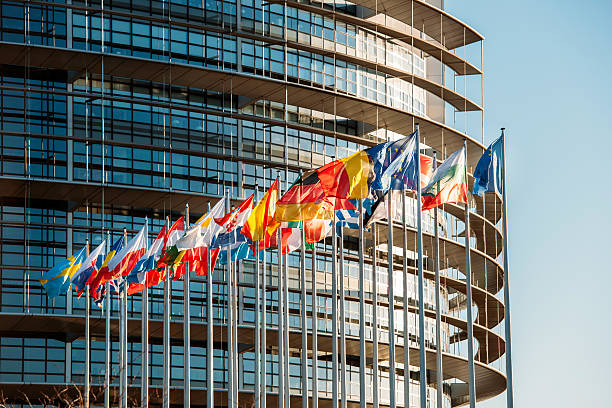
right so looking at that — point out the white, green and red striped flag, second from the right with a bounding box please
[422,147,468,211]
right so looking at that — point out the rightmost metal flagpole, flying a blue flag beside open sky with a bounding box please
[501,128,514,408]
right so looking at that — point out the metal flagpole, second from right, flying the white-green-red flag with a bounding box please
[463,140,476,408]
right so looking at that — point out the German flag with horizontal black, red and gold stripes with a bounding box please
[274,170,355,222]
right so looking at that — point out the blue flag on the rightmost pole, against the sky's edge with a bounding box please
[472,136,503,197]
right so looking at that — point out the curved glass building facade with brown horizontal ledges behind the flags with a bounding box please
[0,0,506,407]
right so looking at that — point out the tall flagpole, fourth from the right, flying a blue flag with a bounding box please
[416,123,427,408]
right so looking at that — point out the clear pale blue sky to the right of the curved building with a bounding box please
[445,0,612,408]
